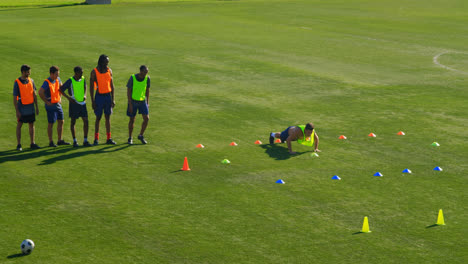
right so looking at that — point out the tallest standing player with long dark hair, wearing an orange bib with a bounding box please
[89,54,116,146]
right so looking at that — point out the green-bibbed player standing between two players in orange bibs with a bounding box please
[60,66,91,147]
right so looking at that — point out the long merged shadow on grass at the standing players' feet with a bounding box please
[0,144,129,165]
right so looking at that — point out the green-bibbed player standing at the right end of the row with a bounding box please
[127,65,151,145]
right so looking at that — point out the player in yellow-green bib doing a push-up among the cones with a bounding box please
[270,123,320,154]
